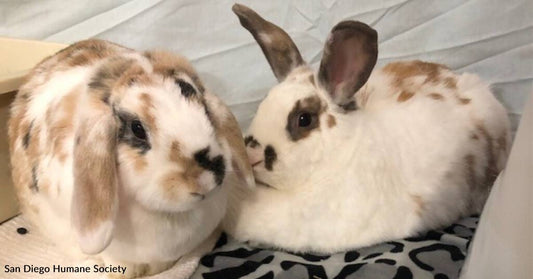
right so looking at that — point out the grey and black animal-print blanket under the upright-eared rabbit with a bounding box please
[192,216,479,279]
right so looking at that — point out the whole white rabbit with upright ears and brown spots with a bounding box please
[224,5,510,253]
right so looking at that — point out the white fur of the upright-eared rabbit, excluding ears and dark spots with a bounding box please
[225,65,510,253]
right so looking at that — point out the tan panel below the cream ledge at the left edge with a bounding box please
[0,92,19,223]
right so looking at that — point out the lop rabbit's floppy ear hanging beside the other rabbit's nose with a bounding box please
[204,93,255,188]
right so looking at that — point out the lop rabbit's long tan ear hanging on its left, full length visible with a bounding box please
[71,95,118,254]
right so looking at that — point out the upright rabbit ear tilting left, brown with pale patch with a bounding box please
[232,4,305,82]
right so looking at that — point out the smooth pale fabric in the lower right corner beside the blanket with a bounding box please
[461,94,533,279]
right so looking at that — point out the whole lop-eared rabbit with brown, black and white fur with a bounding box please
[9,40,254,277]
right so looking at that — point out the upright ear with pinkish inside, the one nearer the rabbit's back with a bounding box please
[318,21,378,109]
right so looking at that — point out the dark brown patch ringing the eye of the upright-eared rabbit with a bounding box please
[285,96,326,141]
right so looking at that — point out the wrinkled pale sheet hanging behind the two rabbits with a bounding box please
[0,0,533,130]
